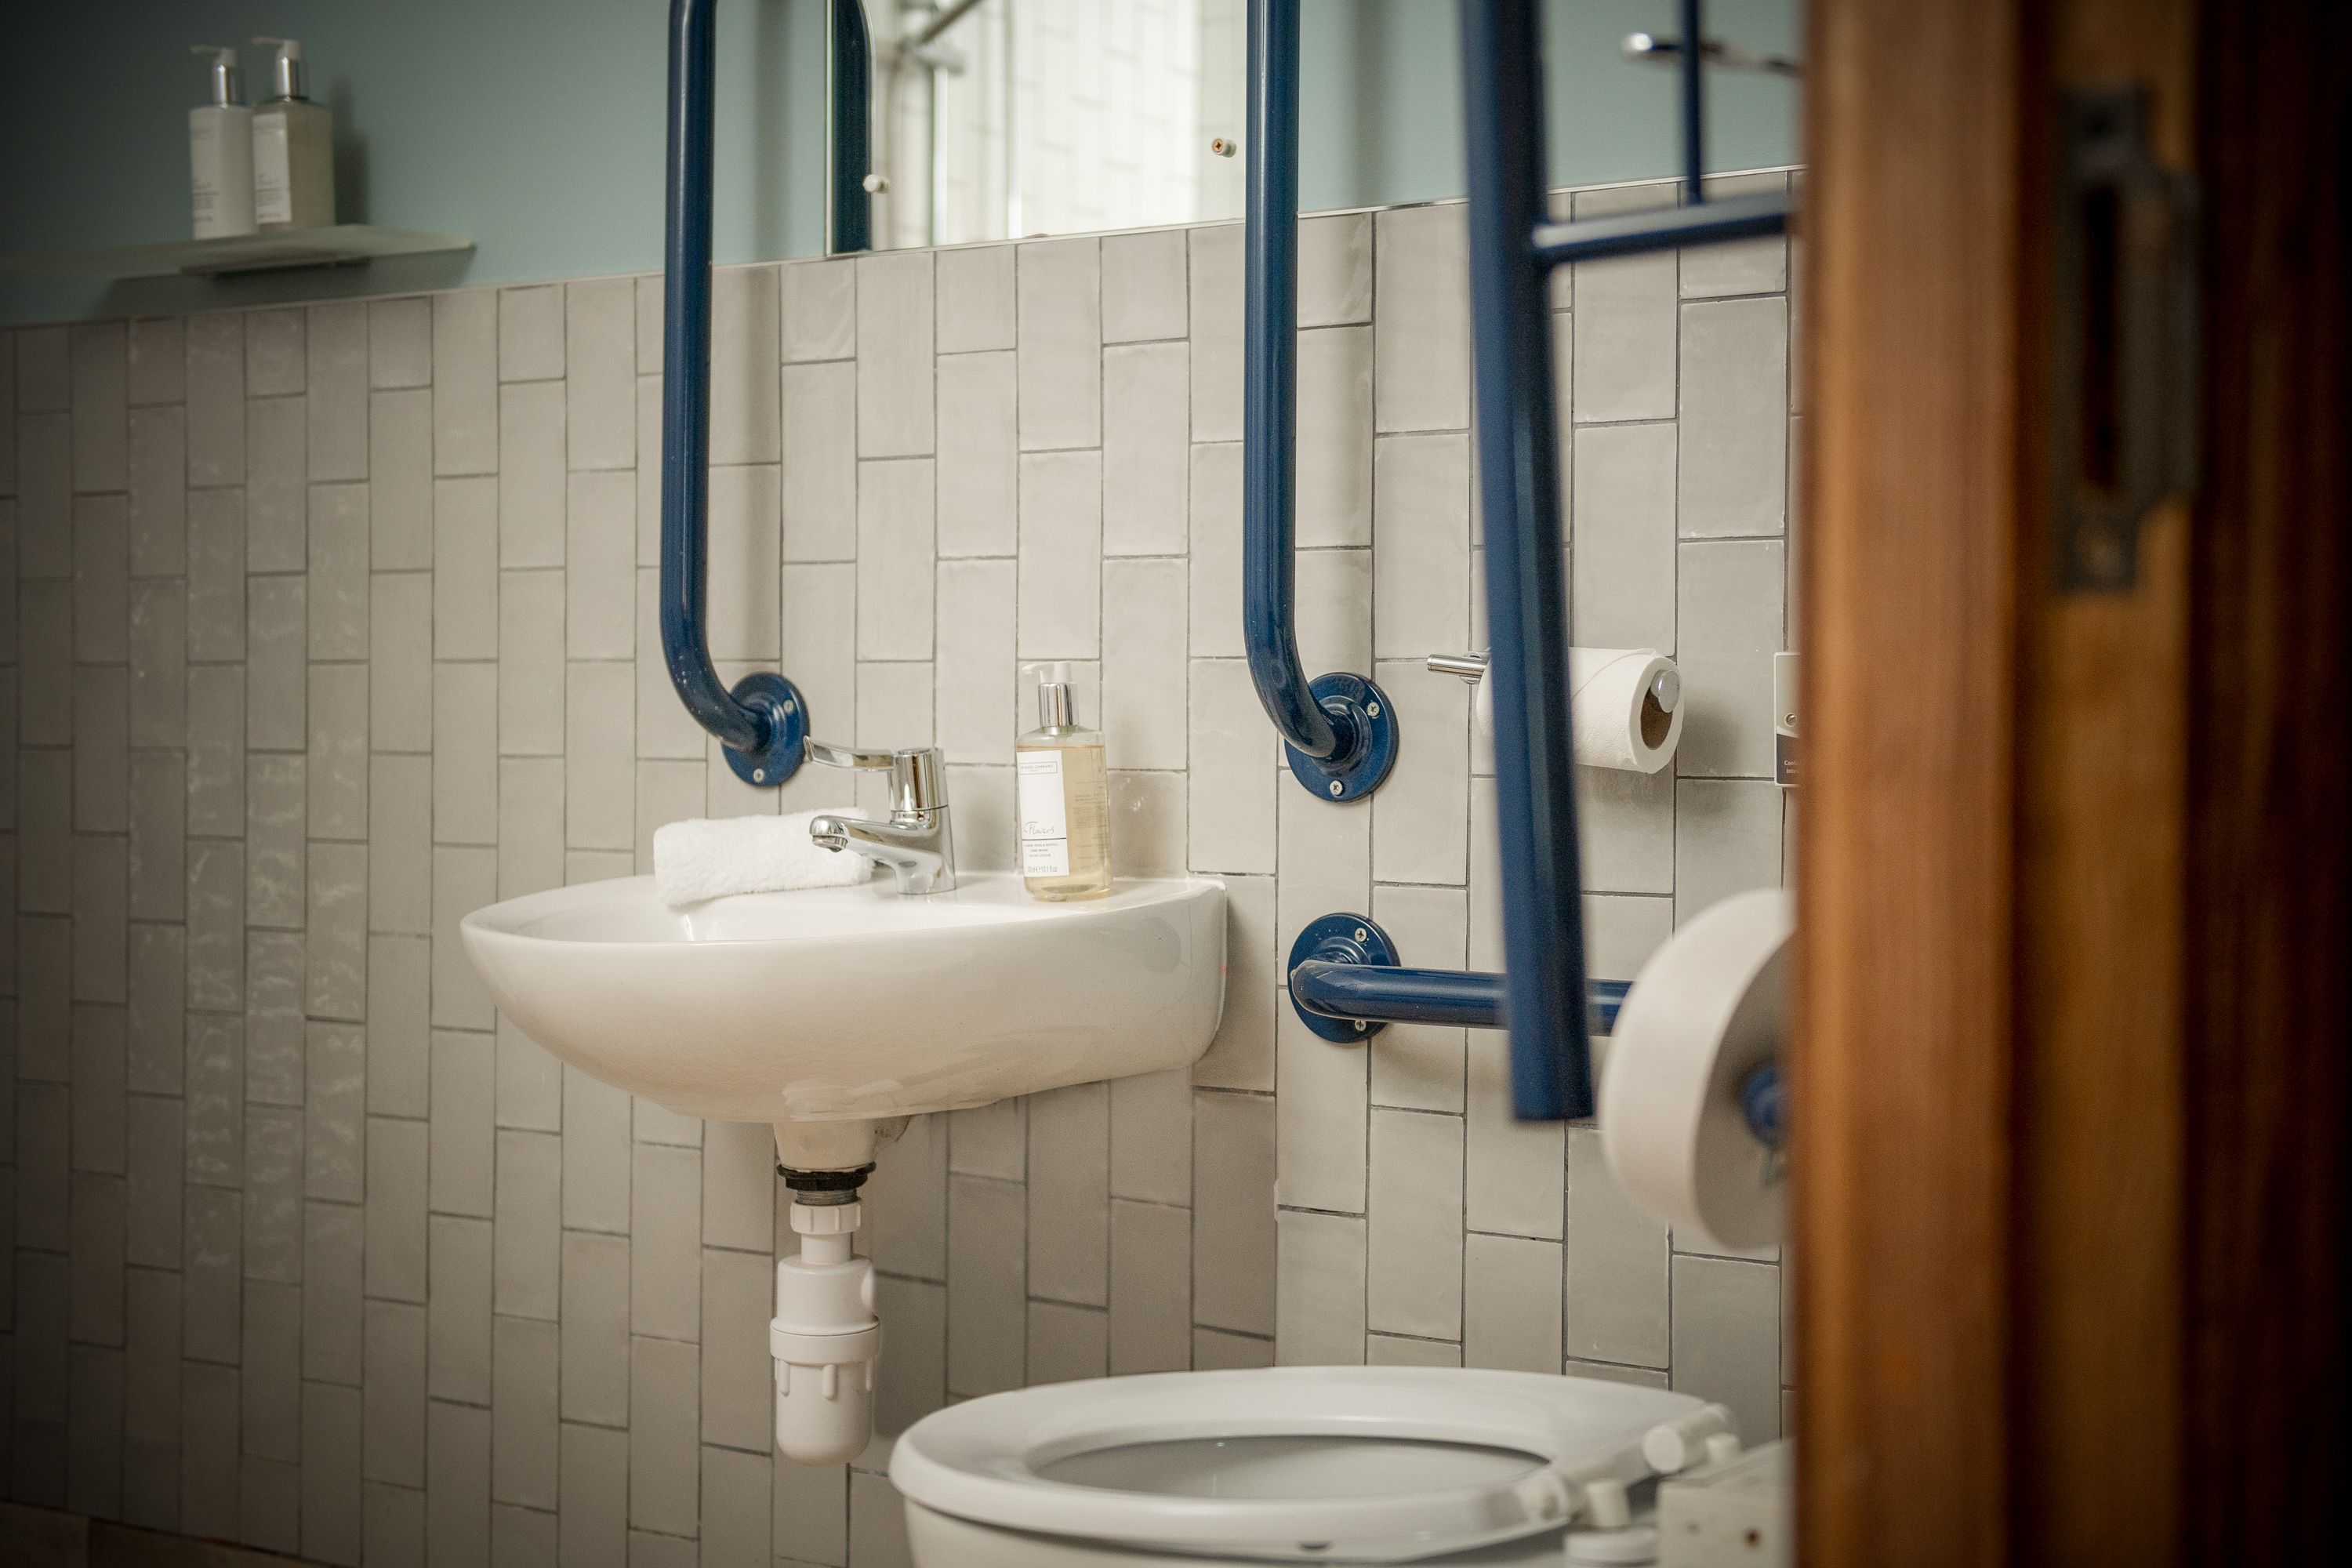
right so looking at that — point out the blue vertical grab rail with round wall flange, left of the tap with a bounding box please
[661,0,809,787]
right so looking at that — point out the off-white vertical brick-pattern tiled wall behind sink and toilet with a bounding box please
[0,174,1792,1568]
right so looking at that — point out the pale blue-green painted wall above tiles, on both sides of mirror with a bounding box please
[0,0,1797,322]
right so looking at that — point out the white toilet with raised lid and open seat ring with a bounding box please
[889,1366,1738,1568]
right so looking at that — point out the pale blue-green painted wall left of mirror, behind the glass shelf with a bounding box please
[0,0,826,320]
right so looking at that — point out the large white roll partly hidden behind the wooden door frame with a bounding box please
[1599,888,1795,1248]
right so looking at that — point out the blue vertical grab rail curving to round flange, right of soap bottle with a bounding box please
[1242,0,1397,801]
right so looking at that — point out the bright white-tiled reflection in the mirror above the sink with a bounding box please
[833,0,1244,252]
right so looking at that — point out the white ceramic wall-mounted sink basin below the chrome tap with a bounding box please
[463,872,1225,1163]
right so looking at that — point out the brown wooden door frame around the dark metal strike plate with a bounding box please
[1792,0,2352,1566]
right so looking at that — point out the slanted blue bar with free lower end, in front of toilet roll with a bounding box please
[1461,0,1592,1119]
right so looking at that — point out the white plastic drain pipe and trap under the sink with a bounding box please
[767,1166,882,1465]
